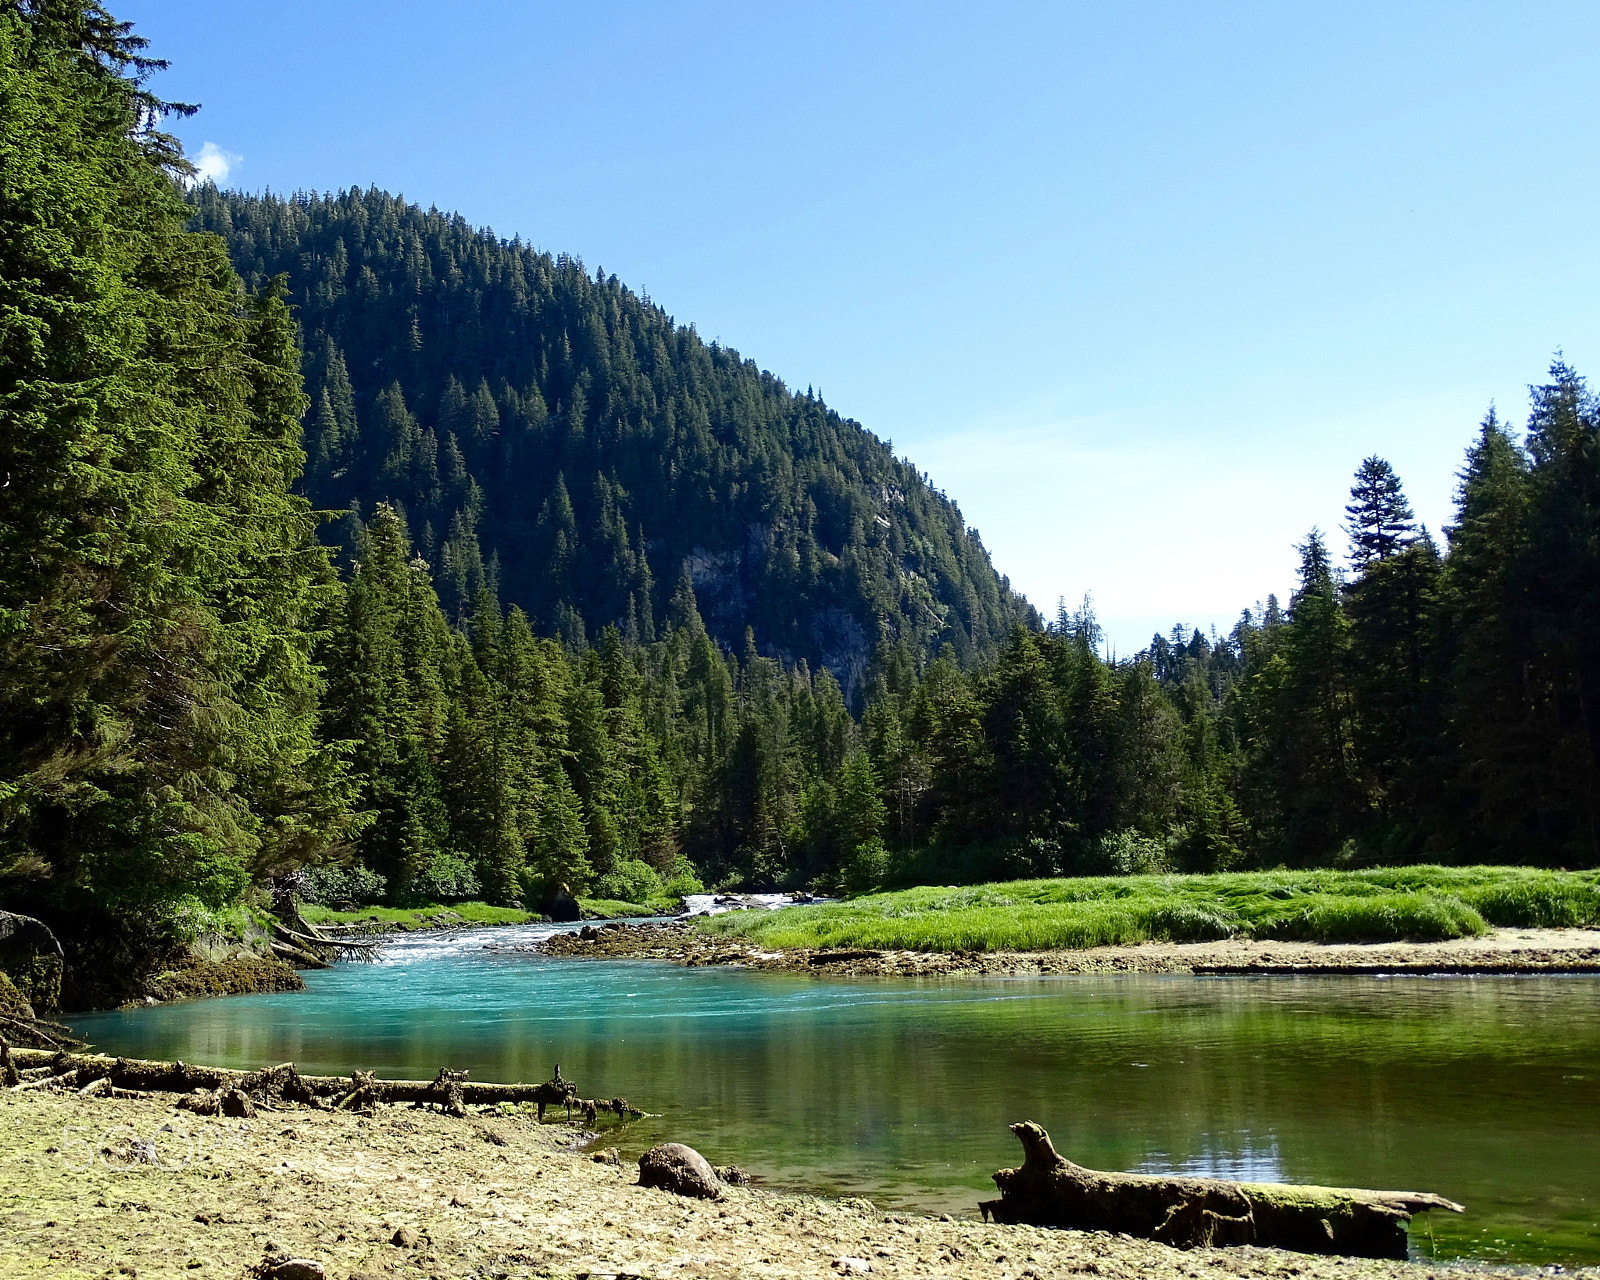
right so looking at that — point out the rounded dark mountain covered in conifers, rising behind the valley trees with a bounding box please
[192,187,1037,696]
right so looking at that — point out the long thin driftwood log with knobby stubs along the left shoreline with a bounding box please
[10,1050,645,1122]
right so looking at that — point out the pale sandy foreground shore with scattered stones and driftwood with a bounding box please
[0,1091,1555,1280]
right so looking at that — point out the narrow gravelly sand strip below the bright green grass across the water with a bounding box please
[539,922,1600,978]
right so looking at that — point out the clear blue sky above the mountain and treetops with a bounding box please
[124,0,1600,653]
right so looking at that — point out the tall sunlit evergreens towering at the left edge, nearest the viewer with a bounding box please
[0,3,349,901]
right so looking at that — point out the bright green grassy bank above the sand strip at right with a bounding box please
[699,867,1600,950]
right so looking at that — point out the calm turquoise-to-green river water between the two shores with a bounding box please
[72,926,1600,1266]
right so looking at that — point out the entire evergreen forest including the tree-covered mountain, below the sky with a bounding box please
[0,0,1600,972]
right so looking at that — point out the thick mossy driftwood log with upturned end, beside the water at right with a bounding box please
[979,1120,1462,1259]
